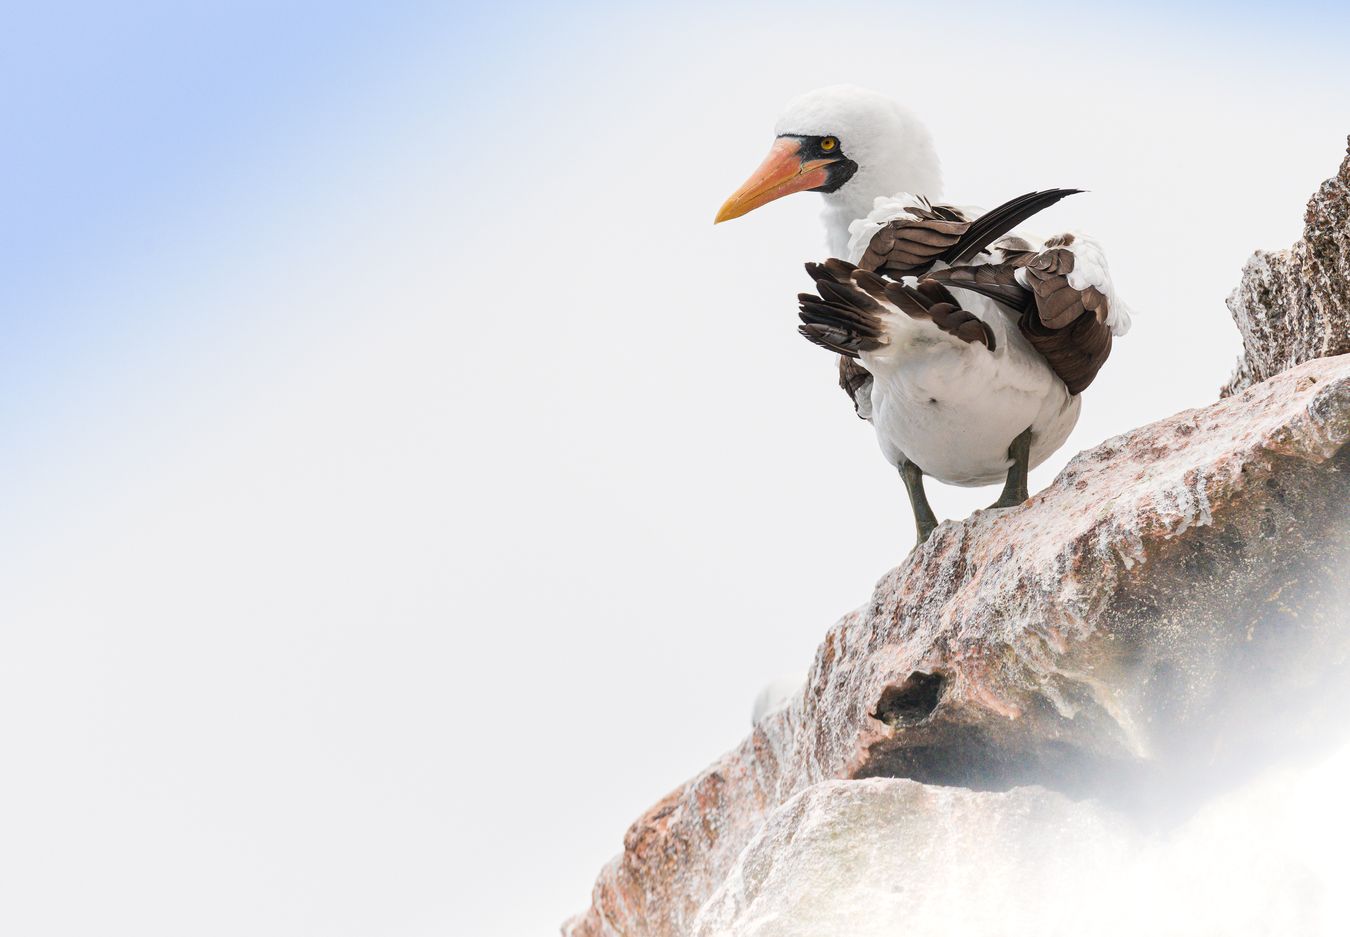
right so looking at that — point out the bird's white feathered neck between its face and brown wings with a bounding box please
[821,117,942,257]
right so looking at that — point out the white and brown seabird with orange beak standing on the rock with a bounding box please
[717,85,1130,543]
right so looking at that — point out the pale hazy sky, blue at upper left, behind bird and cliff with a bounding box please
[0,3,1350,937]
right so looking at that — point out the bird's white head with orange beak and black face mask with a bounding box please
[717,85,942,254]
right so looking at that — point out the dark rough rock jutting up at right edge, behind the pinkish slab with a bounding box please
[1223,135,1350,396]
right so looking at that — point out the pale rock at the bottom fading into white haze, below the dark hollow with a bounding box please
[691,772,1350,937]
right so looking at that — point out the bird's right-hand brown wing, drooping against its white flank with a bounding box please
[929,239,1111,394]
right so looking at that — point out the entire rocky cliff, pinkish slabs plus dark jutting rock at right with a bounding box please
[564,139,1350,937]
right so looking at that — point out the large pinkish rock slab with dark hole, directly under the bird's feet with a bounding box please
[564,355,1350,937]
